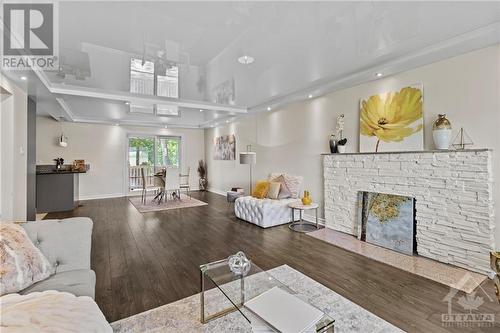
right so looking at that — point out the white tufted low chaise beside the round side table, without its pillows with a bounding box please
[234,196,300,228]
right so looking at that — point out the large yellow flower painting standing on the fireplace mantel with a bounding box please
[359,86,424,152]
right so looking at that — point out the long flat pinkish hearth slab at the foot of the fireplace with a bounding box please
[307,228,487,293]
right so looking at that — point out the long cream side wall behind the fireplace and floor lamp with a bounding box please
[205,45,500,247]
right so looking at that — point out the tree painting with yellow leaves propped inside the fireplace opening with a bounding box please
[358,192,416,255]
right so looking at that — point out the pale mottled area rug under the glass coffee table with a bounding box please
[111,265,403,333]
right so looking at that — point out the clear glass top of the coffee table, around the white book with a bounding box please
[200,259,334,332]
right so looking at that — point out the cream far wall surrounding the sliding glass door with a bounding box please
[36,117,205,199]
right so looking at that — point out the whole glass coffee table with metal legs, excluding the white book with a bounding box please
[200,259,335,332]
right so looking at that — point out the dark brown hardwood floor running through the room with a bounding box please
[46,192,500,332]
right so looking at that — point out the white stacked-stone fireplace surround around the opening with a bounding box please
[323,149,495,273]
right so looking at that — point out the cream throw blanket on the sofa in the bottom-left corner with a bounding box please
[0,290,113,333]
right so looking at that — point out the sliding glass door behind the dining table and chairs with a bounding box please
[128,136,181,191]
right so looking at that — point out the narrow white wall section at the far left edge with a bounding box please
[0,73,28,221]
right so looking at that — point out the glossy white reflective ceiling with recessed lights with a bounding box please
[1,1,500,127]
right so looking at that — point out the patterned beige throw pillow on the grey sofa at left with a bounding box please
[0,223,52,295]
